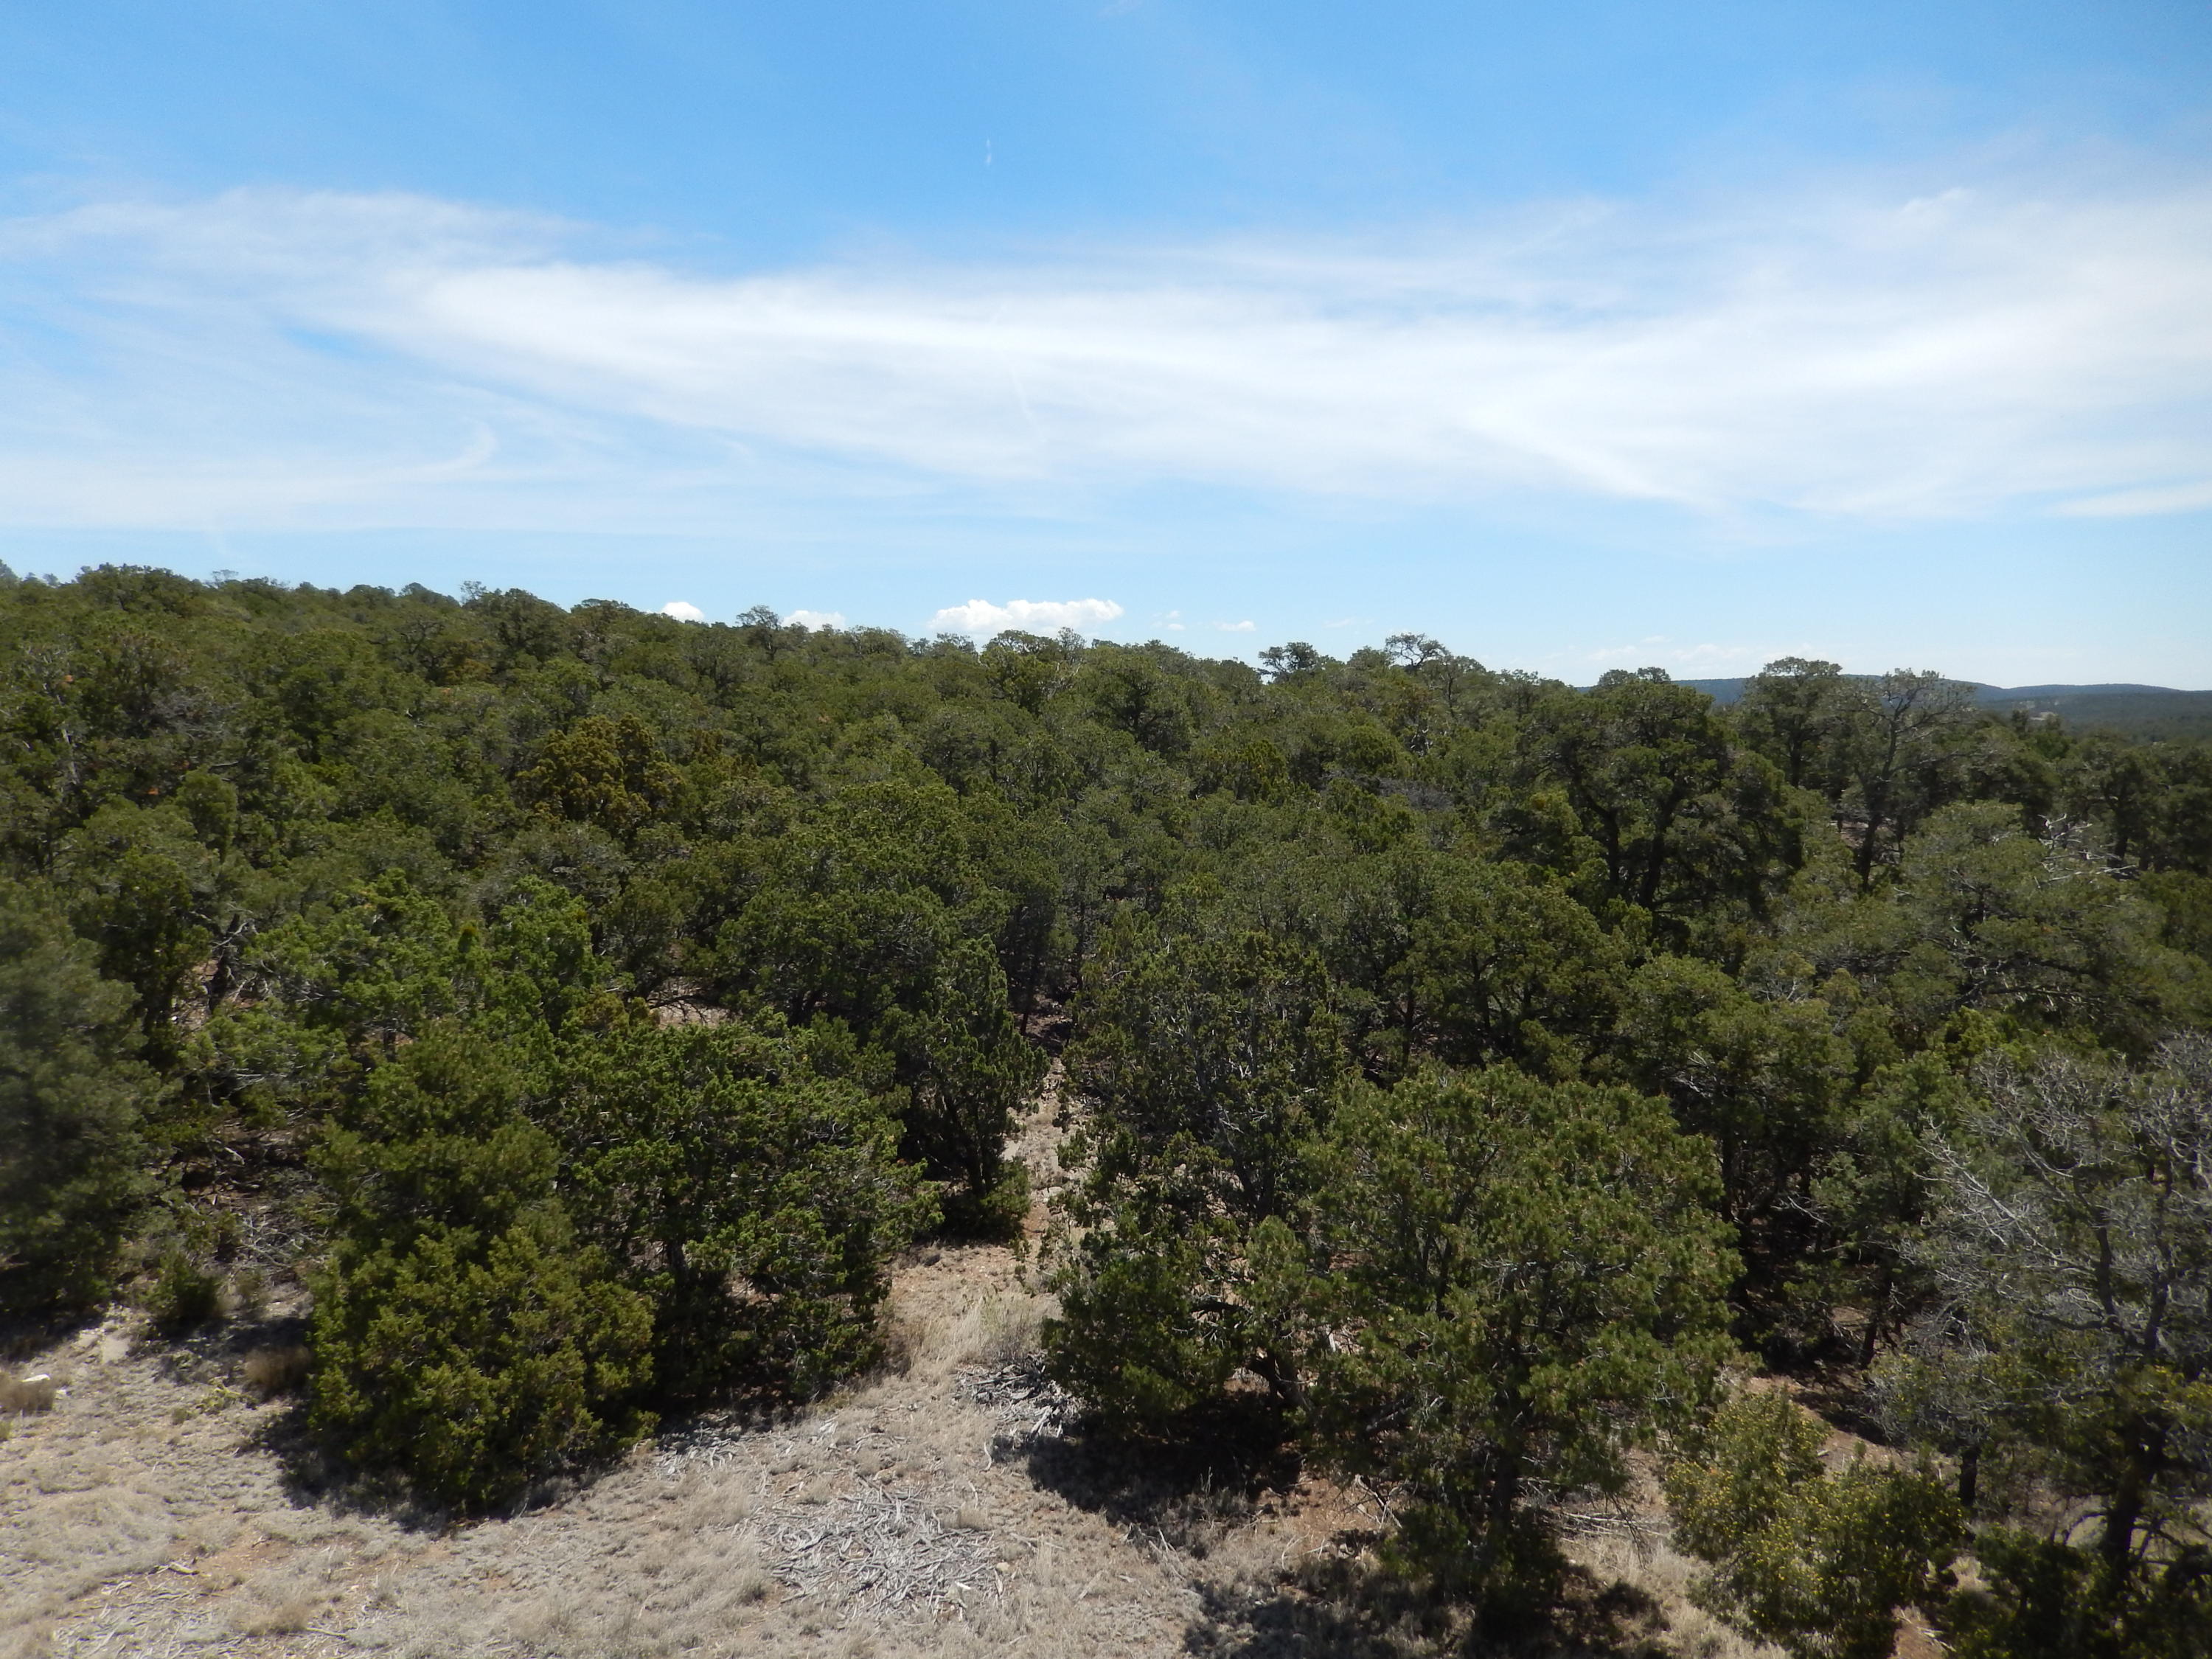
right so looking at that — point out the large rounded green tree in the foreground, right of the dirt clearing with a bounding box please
[1274,1068,1734,1599]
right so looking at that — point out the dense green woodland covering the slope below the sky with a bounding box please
[0,568,2212,1659]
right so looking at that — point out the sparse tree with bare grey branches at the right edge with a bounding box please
[1882,1037,2212,1595]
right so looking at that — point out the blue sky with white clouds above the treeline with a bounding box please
[0,0,2212,686]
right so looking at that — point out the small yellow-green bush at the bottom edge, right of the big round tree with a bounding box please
[1666,1394,1966,1659]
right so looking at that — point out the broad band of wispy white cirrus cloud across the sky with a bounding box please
[0,175,2212,529]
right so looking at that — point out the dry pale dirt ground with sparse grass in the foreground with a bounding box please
[0,1084,1754,1659]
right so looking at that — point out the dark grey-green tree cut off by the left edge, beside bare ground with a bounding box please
[0,883,157,1314]
